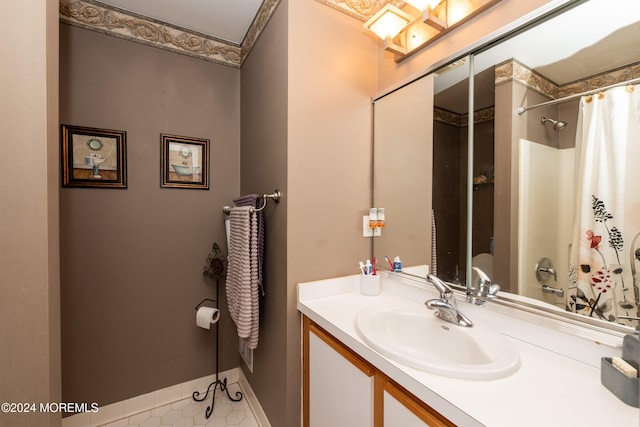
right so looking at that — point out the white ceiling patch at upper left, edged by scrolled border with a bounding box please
[98,0,262,45]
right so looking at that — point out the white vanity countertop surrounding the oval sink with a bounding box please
[298,273,640,427]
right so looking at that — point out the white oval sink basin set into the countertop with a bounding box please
[356,305,520,380]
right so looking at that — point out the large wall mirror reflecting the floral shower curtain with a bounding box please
[373,0,640,327]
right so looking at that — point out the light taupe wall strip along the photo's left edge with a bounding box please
[0,0,60,427]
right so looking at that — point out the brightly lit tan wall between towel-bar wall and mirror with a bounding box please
[288,0,378,426]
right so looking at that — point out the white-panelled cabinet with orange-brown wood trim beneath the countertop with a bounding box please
[302,316,454,427]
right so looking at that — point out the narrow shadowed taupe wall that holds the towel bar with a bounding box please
[241,1,288,427]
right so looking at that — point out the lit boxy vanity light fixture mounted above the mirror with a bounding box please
[364,0,501,62]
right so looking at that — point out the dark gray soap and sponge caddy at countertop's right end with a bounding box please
[600,335,640,408]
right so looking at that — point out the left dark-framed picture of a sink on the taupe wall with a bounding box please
[61,125,127,188]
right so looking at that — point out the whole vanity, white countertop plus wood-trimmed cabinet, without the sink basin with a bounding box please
[298,272,640,427]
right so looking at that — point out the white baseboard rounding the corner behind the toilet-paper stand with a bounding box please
[62,368,262,427]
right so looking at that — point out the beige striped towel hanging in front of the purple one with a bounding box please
[225,206,259,349]
